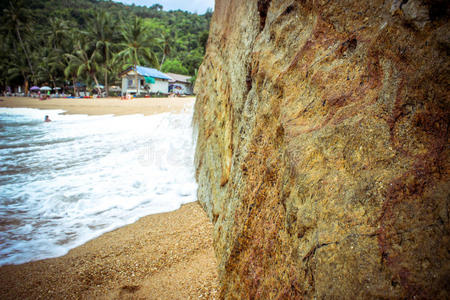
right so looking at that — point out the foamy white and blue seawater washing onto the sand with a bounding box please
[0,107,197,265]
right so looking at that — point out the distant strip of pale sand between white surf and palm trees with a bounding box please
[0,97,195,116]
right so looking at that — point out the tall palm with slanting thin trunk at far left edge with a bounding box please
[3,0,34,85]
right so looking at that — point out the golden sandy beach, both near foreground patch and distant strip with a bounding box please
[0,97,218,299]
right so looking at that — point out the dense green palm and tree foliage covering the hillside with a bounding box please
[0,0,212,95]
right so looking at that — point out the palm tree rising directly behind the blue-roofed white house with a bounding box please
[116,17,159,95]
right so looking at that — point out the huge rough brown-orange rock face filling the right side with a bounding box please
[195,0,450,299]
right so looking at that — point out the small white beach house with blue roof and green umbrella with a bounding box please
[119,66,172,95]
